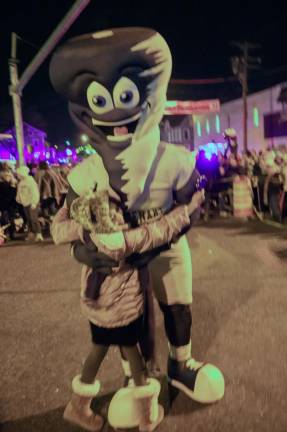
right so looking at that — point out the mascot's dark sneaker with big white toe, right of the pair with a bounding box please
[167,357,224,403]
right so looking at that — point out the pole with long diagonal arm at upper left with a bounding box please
[9,0,91,166]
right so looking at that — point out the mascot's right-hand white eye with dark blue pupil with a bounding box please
[113,77,140,108]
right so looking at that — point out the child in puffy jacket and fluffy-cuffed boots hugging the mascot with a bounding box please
[51,191,204,431]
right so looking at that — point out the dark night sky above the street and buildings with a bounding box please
[0,0,287,144]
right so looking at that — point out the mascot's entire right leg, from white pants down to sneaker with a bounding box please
[150,236,224,403]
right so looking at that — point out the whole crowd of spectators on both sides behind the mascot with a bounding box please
[0,146,287,243]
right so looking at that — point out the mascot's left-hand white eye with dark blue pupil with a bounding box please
[87,81,114,114]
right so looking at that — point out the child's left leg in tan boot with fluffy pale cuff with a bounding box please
[63,344,109,432]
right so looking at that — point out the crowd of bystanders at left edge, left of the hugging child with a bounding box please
[0,161,71,244]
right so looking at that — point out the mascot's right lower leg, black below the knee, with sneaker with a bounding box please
[159,303,224,403]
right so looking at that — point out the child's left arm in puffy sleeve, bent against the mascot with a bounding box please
[51,205,83,245]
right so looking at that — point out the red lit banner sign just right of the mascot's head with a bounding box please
[164,99,220,115]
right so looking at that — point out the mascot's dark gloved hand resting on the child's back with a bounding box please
[72,240,119,274]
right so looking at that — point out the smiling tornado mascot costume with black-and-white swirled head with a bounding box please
[50,27,224,427]
